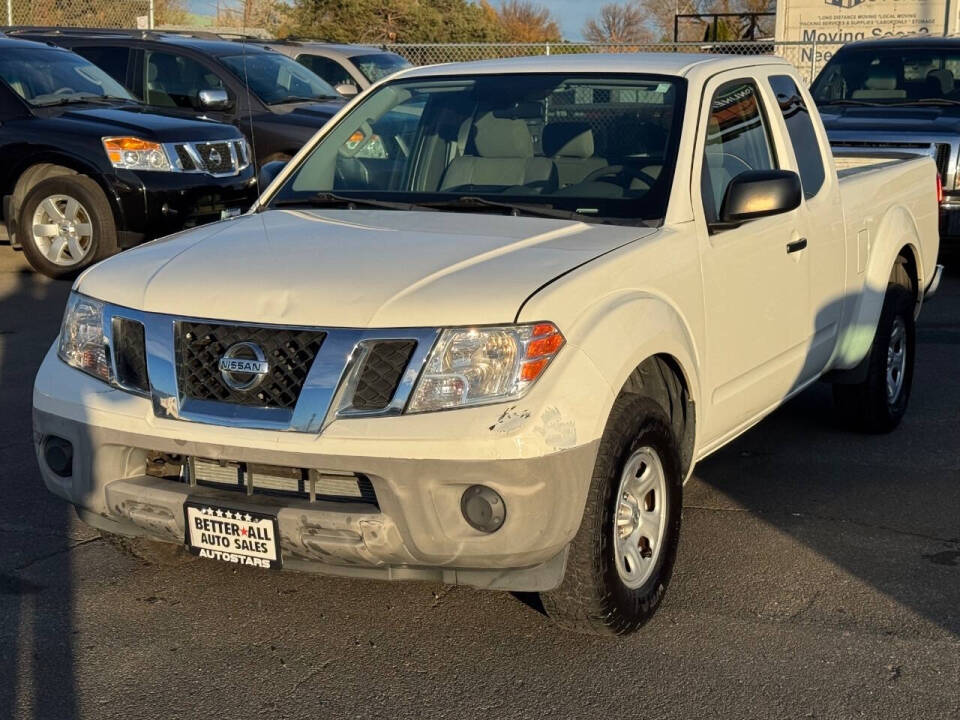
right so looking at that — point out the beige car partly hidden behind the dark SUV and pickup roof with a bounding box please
[267,39,411,97]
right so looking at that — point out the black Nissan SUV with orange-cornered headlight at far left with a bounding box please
[0,36,256,277]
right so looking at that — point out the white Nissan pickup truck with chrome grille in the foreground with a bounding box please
[34,54,939,634]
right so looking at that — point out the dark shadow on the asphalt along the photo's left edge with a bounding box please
[0,266,77,719]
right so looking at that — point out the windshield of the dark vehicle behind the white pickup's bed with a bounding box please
[811,47,960,105]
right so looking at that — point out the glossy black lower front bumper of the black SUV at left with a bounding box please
[104,166,257,247]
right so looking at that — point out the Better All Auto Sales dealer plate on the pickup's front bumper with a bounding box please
[183,500,281,568]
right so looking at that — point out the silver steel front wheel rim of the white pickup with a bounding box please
[613,447,667,589]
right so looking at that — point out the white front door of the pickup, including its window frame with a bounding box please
[691,71,810,443]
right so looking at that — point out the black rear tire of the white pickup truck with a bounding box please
[833,283,916,433]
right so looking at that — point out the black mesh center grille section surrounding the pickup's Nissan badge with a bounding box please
[176,321,325,409]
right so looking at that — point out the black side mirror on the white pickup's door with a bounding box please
[711,170,803,230]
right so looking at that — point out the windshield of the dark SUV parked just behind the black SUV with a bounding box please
[220,52,340,105]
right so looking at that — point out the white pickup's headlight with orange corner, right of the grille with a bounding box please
[407,323,564,413]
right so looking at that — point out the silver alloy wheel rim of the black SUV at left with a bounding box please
[31,194,93,266]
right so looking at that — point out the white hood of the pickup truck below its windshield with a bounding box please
[77,209,656,328]
